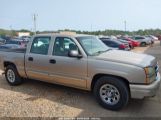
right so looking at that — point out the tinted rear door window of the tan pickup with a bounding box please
[30,37,51,55]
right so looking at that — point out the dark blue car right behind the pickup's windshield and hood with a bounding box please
[100,38,130,51]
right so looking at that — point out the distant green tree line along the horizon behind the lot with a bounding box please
[0,29,161,36]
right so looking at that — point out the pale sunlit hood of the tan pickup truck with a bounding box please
[96,50,156,67]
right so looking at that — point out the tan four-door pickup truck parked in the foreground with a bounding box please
[0,34,160,110]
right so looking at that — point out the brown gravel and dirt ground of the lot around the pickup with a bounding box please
[0,42,161,117]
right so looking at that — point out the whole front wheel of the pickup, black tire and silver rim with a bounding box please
[93,76,130,111]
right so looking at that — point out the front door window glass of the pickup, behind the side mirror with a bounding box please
[53,37,78,56]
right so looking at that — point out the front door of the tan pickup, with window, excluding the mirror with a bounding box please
[49,37,87,88]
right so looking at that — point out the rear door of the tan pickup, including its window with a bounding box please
[25,36,51,80]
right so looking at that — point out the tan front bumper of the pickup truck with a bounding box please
[130,72,160,99]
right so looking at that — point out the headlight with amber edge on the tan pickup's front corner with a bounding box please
[144,67,155,84]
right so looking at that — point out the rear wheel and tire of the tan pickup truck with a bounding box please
[5,65,23,86]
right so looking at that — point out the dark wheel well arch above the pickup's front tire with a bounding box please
[91,74,130,91]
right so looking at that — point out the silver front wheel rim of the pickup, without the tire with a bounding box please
[100,84,120,105]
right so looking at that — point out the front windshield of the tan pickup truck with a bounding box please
[76,36,109,56]
